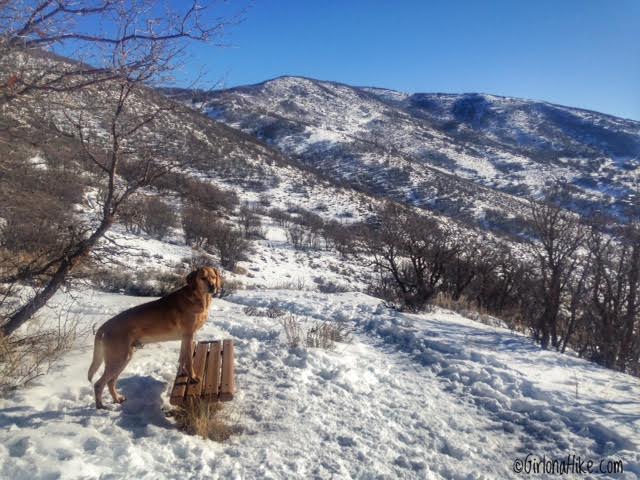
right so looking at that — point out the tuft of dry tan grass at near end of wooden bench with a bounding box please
[170,399,241,442]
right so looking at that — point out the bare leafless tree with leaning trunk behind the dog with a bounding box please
[0,0,235,335]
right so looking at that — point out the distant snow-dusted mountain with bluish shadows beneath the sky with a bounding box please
[180,77,640,224]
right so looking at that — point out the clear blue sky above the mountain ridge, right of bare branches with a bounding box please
[174,0,640,120]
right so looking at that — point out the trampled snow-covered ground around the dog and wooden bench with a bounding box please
[0,290,640,480]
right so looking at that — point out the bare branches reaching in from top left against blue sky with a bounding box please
[0,0,232,100]
